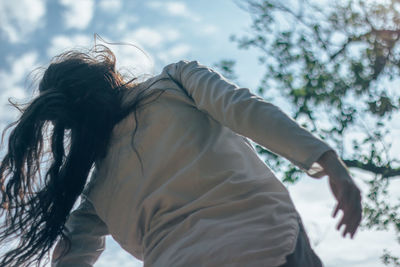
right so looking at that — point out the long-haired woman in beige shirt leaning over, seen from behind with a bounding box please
[0,48,361,266]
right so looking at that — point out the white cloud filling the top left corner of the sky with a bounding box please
[0,0,46,43]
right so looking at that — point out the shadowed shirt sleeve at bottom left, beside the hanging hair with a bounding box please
[51,196,108,267]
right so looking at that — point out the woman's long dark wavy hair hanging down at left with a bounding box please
[0,46,161,267]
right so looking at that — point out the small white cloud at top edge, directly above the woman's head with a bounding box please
[60,0,94,30]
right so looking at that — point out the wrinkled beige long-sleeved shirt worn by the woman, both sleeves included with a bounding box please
[52,61,331,267]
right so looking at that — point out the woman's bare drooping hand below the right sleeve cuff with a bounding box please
[317,151,362,238]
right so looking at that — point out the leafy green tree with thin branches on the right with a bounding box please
[217,0,400,266]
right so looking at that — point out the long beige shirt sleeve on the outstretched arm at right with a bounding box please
[163,61,332,177]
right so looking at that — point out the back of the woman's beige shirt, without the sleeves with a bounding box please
[69,62,330,266]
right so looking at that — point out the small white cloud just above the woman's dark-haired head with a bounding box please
[47,34,93,57]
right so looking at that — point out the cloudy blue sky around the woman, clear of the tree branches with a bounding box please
[0,0,400,267]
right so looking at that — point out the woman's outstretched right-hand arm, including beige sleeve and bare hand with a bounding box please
[164,61,361,237]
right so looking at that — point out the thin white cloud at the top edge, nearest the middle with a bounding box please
[147,1,201,21]
